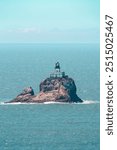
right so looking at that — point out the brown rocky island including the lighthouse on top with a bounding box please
[7,62,83,103]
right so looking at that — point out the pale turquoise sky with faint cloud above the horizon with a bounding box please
[0,0,100,43]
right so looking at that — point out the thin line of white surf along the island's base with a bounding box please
[0,100,100,105]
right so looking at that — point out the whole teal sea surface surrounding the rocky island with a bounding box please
[0,44,100,150]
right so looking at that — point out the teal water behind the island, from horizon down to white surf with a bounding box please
[0,44,100,101]
